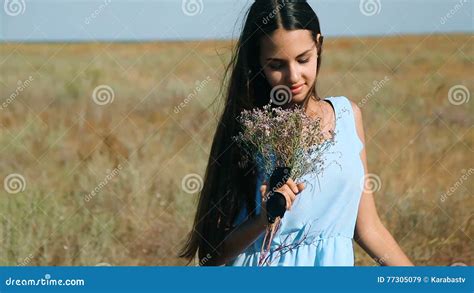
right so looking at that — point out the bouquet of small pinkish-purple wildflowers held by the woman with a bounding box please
[233,104,335,259]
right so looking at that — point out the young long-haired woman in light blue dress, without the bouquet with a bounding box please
[180,0,413,266]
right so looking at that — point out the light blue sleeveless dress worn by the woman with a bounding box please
[226,96,364,266]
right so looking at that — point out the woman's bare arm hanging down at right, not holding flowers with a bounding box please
[351,102,413,266]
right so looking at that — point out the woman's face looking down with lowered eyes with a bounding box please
[260,28,317,104]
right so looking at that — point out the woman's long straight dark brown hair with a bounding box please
[179,0,323,265]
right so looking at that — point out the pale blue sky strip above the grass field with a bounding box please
[0,0,474,41]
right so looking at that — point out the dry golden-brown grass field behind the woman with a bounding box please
[0,35,474,266]
